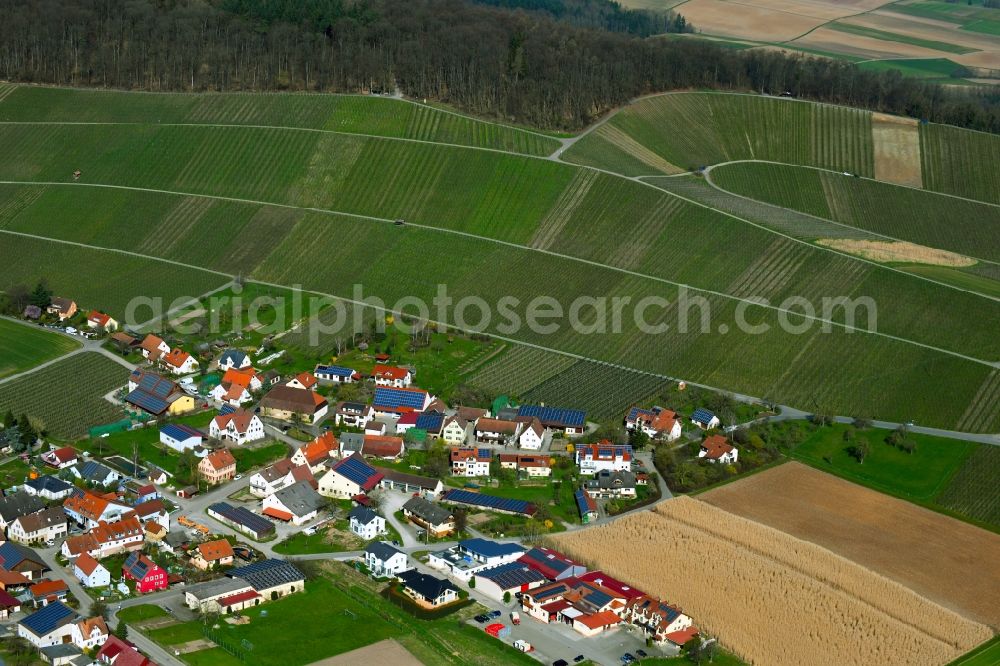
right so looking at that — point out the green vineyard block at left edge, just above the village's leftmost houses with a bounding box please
[0,228,228,322]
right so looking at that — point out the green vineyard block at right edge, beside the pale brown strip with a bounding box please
[920,125,1000,203]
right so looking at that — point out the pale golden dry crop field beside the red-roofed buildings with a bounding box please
[551,496,992,666]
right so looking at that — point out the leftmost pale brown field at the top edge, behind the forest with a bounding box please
[676,0,825,42]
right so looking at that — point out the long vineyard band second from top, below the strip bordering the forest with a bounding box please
[0,120,1000,360]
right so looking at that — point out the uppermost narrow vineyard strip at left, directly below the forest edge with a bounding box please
[0,86,559,155]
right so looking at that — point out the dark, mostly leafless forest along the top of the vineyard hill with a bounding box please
[0,0,1000,132]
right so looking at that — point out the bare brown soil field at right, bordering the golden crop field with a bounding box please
[699,463,1000,627]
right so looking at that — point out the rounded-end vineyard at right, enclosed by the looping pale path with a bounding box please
[712,163,1000,261]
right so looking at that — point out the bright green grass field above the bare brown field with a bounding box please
[791,424,976,502]
